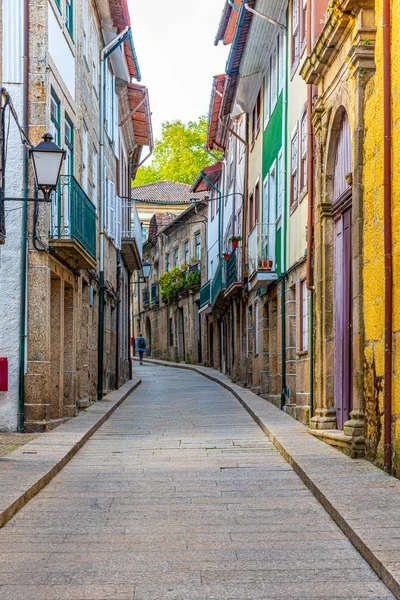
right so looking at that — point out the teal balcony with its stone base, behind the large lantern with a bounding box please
[49,175,96,269]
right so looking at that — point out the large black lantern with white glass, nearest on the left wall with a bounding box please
[30,133,66,200]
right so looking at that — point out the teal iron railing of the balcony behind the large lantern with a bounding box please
[50,175,96,258]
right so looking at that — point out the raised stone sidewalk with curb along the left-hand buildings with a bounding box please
[0,378,141,527]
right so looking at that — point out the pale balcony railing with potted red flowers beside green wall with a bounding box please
[247,223,276,277]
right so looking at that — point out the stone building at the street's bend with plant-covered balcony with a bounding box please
[135,202,207,363]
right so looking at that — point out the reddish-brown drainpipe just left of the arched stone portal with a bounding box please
[306,4,315,419]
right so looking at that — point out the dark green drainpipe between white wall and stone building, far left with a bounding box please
[17,0,29,433]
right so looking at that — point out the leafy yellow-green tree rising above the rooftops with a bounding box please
[133,117,219,186]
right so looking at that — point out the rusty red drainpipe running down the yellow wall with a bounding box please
[382,0,393,470]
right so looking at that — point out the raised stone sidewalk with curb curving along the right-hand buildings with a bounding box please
[138,359,400,599]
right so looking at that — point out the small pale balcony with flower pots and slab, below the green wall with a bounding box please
[247,223,278,291]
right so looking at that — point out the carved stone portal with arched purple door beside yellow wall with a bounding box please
[302,1,376,456]
